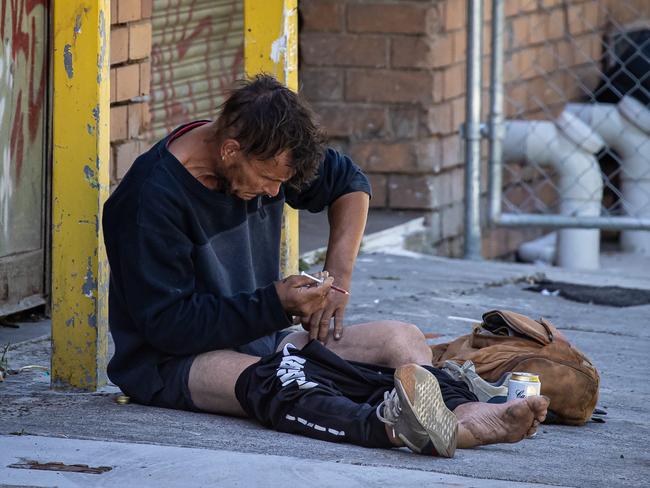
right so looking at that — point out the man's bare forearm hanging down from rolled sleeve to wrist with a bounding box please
[325,192,370,289]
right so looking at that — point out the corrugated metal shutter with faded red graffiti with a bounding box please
[150,0,244,139]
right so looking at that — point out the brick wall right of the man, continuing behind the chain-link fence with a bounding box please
[300,0,647,257]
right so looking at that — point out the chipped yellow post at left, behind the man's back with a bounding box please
[51,0,111,391]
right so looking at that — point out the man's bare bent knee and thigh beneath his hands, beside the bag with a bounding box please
[278,320,431,368]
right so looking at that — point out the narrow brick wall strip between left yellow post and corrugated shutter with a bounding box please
[111,0,153,186]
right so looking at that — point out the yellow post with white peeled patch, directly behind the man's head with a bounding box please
[244,0,299,276]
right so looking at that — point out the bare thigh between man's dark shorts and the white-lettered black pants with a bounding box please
[188,351,260,417]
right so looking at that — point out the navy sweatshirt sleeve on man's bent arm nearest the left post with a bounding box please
[112,217,291,355]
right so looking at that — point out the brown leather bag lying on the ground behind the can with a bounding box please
[431,310,600,425]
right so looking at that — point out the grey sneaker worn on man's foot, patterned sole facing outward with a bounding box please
[377,364,458,457]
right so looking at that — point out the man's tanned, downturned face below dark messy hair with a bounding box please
[223,151,294,200]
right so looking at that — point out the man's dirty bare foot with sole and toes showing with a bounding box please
[454,396,549,449]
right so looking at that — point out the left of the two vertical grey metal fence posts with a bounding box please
[463,0,483,260]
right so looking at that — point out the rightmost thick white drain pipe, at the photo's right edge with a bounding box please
[565,95,650,255]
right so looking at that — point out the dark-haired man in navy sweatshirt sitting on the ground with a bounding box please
[103,76,548,456]
